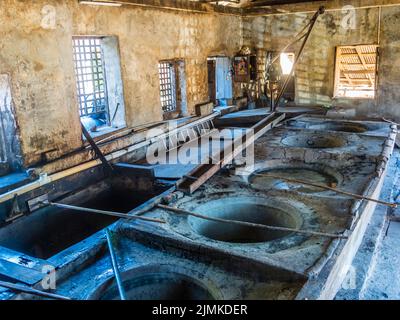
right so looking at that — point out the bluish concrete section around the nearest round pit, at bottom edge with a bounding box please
[33,231,302,300]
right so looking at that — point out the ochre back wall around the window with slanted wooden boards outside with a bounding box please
[243,2,400,121]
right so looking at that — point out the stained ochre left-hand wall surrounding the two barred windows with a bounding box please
[0,0,242,165]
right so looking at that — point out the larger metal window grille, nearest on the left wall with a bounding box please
[73,37,109,121]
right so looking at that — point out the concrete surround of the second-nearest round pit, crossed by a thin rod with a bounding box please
[123,179,353,275]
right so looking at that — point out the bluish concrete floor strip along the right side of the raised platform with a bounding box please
[336,149,400,300]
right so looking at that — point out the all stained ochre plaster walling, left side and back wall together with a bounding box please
[0,0,400,170]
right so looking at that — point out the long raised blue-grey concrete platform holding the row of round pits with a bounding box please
[3,117,393,299]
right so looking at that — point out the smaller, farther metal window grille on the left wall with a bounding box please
[159,62,176,112]
